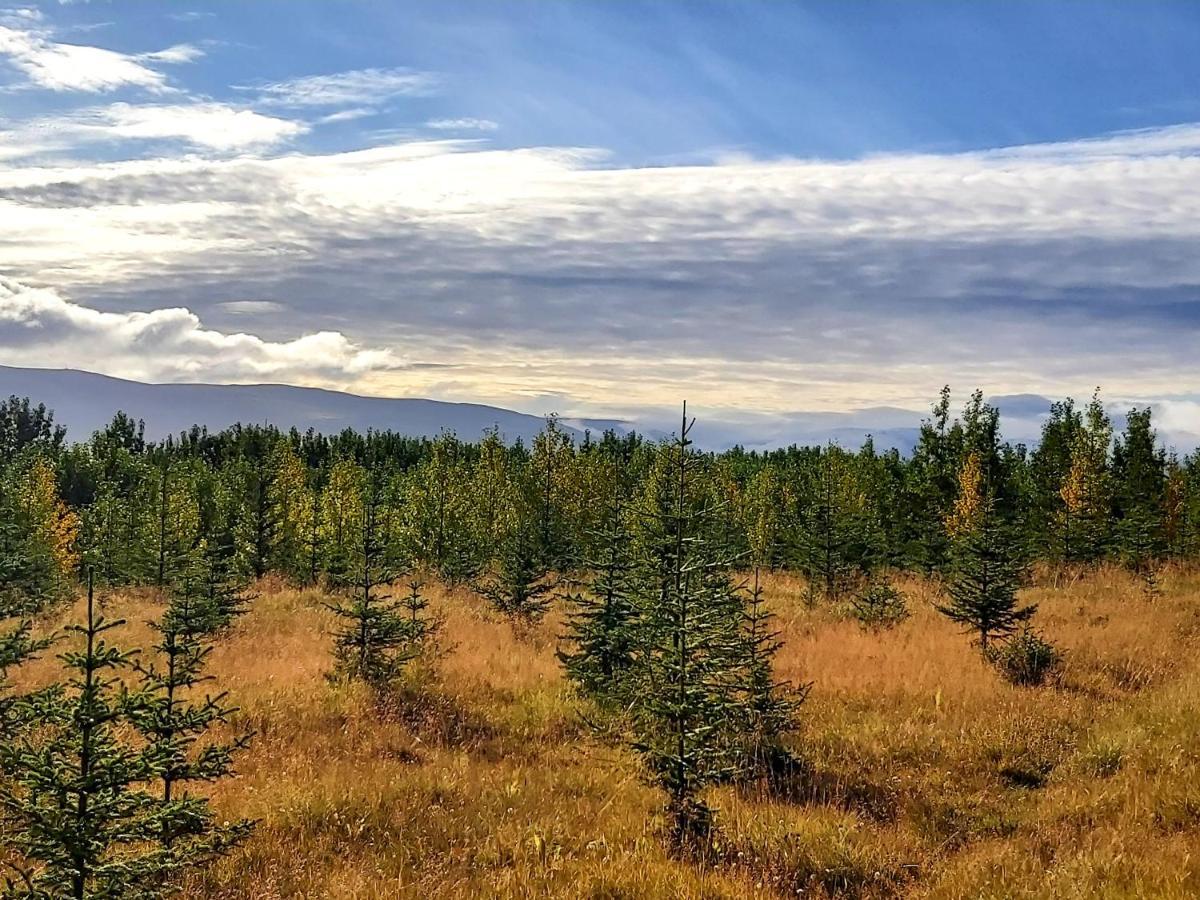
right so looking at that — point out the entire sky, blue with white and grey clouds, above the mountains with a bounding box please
[0,0,1200,438]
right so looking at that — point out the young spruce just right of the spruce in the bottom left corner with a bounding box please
[132,592,253,865]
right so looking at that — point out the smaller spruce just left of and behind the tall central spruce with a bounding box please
[558,482,638,701]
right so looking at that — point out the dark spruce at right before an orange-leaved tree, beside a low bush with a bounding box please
[937,492,1037,655]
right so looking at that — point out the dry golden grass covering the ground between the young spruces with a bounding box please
[9,569,1200,900]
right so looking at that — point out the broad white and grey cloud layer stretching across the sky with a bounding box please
[0,7,1200,436]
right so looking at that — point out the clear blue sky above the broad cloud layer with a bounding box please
[13,0,1200,164]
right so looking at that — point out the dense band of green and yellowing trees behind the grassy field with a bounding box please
[0,390,1200,602]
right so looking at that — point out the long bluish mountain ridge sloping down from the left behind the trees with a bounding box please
[0,366,580,443]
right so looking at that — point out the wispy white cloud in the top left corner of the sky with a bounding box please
[0,17,199,94]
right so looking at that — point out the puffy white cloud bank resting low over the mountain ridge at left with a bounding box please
[0,278,398,385]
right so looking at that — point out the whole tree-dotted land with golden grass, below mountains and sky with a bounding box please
[0,389,1200,898]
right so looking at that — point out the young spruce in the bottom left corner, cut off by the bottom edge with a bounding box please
[0,575,188,900]
